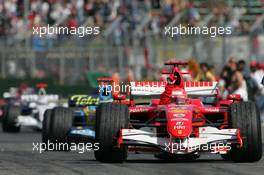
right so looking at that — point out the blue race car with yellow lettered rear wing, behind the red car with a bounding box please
[42,79,113,147]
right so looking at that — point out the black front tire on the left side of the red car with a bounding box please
[94,103,129,163]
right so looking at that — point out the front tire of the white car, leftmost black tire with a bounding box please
[2,106,21,133]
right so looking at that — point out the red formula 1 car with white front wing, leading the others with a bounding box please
[95,61,262,162]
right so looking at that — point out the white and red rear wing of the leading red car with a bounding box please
[131,82,218,96]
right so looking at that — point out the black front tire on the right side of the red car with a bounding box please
[229,102,262,162]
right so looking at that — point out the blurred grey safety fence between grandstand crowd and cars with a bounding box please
[0,35,264,85]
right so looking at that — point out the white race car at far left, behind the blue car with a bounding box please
[2,84,59,132]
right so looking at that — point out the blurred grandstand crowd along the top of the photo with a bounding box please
[0,0,262,42]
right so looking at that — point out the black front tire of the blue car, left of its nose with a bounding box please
[48,107,73,151]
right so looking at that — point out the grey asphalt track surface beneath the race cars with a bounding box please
[0,128,264,175]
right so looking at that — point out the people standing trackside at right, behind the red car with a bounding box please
[184,57,264,101]
